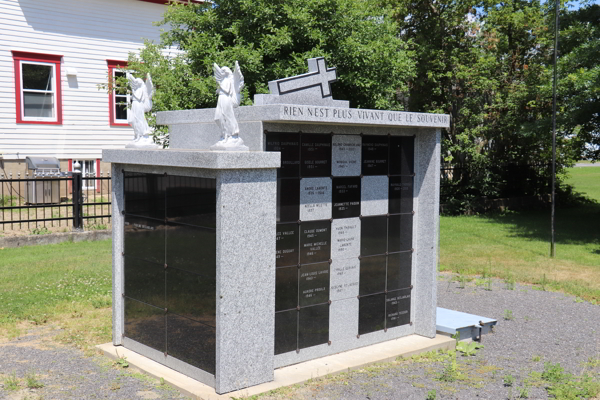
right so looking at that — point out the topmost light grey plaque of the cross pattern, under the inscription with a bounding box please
[331,135,361,176]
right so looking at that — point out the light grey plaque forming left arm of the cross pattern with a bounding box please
[300,178,332,221]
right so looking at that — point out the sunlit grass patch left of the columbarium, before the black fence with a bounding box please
[0,240,112,349]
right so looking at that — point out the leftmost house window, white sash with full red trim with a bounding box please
[12,51,62,124]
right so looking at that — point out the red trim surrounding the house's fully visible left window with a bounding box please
[12,50,62,125]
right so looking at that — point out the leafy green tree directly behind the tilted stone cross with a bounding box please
[129,0,414,146]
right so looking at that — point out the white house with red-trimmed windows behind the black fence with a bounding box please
[0,0,192,176]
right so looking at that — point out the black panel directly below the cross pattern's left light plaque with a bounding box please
[300,220,331,264]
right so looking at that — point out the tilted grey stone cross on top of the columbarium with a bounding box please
[269,57,337,97]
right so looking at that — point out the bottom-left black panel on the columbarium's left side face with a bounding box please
[125,298,167,353]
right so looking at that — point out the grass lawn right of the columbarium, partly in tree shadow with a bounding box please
[440,167,600,303]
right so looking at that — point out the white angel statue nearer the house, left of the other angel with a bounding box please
[125,72,158,148]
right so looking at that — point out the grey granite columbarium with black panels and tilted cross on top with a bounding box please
[103,57,449,394]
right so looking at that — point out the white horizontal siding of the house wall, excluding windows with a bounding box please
[0,0,165,160]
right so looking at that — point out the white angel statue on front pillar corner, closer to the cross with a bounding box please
[210,61,248,151]
